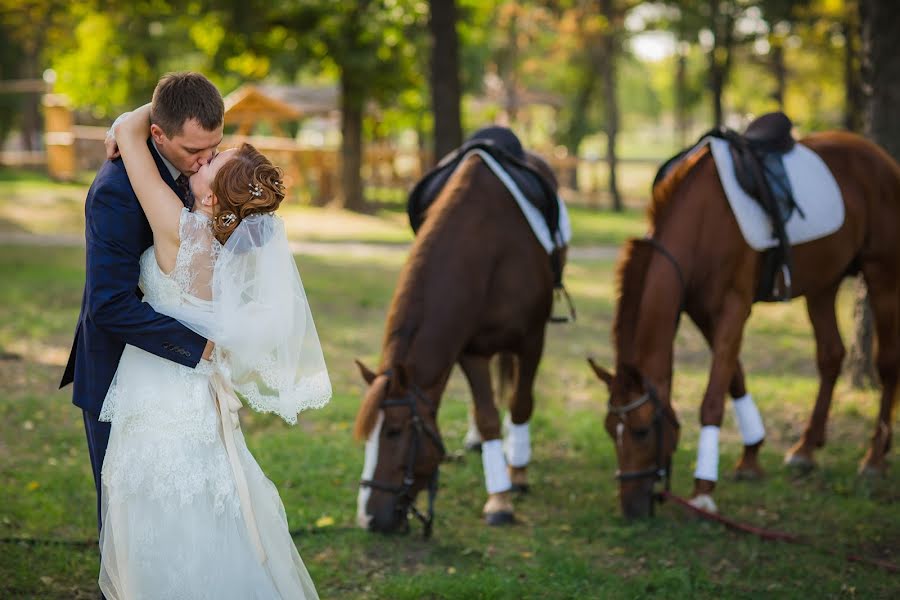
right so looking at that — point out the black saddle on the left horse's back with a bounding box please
[406,127,562,288]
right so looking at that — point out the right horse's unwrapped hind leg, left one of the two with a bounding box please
[784,282,845,469]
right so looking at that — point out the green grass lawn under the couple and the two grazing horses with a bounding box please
[0,241,900,600]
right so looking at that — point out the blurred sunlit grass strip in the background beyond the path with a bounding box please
[0,167,652,246]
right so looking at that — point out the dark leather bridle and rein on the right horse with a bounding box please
[607,236,686,515]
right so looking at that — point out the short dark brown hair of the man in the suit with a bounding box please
[150,72,225,138]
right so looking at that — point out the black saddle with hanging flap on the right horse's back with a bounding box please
[653,112,805,302]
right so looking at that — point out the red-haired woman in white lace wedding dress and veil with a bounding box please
[100,105,331,600]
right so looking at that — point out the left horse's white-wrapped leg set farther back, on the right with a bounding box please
[503,336,544,493]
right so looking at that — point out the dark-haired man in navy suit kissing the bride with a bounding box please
[60,73,225,526]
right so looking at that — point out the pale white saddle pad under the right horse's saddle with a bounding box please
[712,138,844,250]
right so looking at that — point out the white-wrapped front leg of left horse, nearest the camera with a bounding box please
[459,354,515,525]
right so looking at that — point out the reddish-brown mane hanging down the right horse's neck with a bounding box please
[613,239,653,370]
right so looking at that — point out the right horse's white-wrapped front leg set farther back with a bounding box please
[691,314,766,481]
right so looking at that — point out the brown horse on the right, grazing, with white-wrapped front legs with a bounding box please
[591,132,900,516]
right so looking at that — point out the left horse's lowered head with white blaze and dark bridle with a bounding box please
[354,361,445,536]
